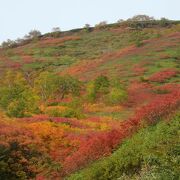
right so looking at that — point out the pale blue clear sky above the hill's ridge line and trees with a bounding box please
[0,0,180,43]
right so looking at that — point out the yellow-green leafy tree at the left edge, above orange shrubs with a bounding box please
[0,71,39,117]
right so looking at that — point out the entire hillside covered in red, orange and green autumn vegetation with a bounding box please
[0,21,180,180]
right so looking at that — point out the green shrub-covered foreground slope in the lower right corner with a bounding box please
[69,112,180,180]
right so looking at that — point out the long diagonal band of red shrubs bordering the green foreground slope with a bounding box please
[60,87,180,174]
